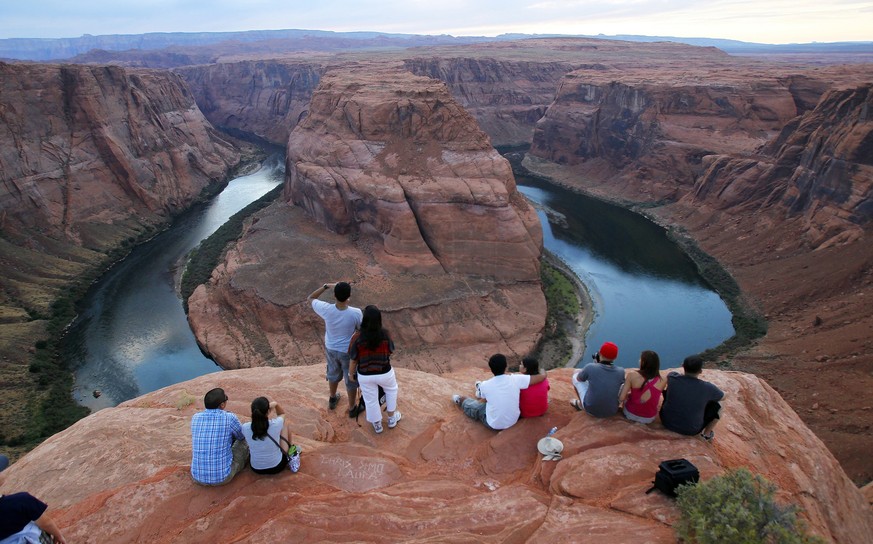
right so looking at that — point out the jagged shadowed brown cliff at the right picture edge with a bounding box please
[692,85,873,247]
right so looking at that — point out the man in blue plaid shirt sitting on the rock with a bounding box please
[191,388,249,485]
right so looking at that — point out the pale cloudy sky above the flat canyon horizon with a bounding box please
[0,0,873,44]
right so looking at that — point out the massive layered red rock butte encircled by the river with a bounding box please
[189,65,546,372]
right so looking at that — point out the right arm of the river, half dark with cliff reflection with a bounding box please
[516,173,734,368]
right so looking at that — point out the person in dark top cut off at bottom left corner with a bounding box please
[0,455,67,544]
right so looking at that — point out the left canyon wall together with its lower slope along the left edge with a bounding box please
[0,63,240,446]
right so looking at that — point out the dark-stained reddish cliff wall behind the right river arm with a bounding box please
[530,67,798,198]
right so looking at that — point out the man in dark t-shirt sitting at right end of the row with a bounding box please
[661,355,724,441]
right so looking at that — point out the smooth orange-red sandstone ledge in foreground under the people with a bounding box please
[2,365,873,544]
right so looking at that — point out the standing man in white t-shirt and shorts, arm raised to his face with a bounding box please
[309,281,363,417]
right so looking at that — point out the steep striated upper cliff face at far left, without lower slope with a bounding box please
[0,64,239,249]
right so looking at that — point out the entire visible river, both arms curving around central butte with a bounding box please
[65,152,733,410]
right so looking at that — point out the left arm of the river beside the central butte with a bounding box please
[70,156,283,410]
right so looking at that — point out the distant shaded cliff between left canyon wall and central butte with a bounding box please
[176,60,325,146]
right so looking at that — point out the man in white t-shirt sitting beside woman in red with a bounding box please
[452,353,546,431]
